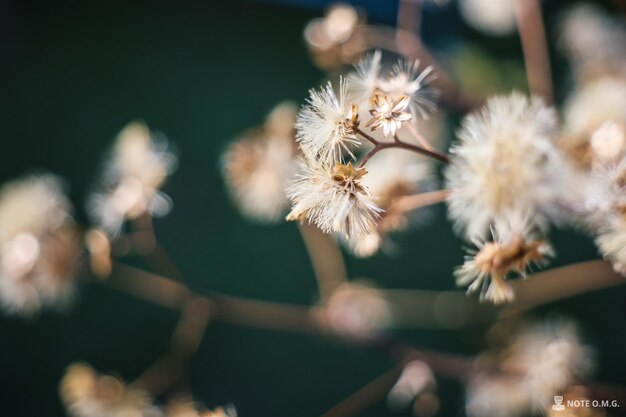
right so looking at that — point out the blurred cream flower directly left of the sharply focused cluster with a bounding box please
[222,103,297,223]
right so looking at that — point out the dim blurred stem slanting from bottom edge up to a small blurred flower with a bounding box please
[322,366,402,417]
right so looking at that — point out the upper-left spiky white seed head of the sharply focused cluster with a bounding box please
[296,79,360,164]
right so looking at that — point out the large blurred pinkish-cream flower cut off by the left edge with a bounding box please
[0,175,80,315]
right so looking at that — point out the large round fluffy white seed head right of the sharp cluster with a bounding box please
[445,93,569,240]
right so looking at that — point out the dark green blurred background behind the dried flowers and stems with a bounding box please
[0,1,626,417]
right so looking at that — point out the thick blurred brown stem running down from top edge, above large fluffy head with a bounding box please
[515,0,554,103]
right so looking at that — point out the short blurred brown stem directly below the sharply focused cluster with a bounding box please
[300,224,348,301]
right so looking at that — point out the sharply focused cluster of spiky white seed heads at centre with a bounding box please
[288,52,434,244]
